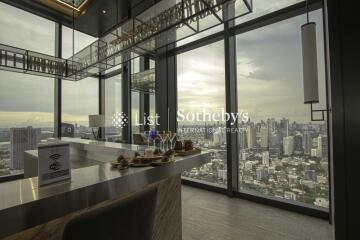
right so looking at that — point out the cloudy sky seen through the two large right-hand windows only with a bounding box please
[177,5,325,123]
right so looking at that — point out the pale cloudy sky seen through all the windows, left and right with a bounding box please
[0,0,325,127]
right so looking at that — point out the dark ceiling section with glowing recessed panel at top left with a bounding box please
[0,0,156,37]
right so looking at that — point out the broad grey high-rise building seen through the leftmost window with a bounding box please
[10,127,41,169]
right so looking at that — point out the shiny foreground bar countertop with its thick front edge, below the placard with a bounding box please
[0,152,211,238]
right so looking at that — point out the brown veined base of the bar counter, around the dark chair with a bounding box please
[5,175,182,240]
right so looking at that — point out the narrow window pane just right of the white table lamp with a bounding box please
[105,74,122,142]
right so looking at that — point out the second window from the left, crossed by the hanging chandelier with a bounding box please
[61,26,99,138]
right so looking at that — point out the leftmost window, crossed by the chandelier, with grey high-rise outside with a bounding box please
[0,3,55,178]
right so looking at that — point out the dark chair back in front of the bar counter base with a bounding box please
[63,187,157,240]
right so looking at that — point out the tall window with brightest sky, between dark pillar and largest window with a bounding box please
[177,41,226,186]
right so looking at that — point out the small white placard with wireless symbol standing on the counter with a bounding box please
[38,143,71,186]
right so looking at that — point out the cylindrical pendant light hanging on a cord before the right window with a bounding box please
[301,2,319,104]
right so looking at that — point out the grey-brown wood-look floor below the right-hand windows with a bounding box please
[182,186,333,240]
